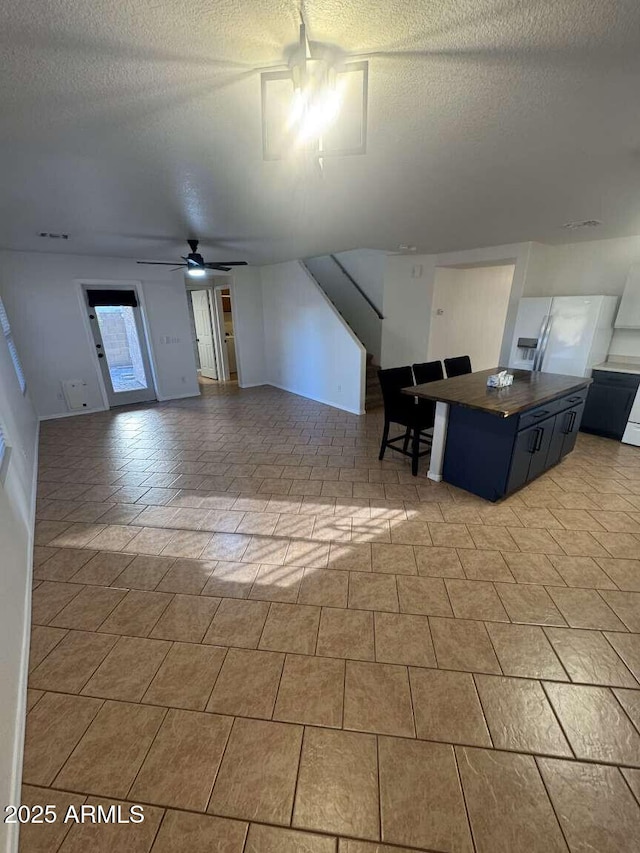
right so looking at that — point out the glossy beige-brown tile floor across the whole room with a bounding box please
[22,385,640,853]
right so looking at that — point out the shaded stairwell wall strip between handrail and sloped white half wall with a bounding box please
[305,255,382,364]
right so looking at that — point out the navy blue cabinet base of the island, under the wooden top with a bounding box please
[442,387,587,501]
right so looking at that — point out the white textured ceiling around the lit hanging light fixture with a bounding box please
[0,0,640,263]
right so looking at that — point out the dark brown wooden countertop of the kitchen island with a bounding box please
[402,367,593,418]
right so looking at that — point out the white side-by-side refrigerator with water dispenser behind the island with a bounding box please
[509,296,618,376]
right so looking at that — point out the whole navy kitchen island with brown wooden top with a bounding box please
[403,367,592,501]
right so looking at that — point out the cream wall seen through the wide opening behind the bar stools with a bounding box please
[427,264,515,370]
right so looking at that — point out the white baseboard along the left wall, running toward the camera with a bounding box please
[6,422,40,853]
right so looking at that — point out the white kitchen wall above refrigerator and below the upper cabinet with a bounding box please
[525,237,640,358]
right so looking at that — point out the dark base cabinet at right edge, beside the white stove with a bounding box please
[582,370,640,441]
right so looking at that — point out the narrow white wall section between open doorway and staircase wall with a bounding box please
[231,267,266,388]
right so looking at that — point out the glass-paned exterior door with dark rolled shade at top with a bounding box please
[85,287,156,408]
